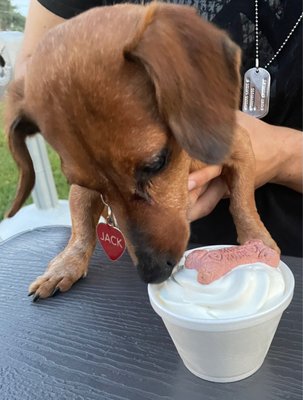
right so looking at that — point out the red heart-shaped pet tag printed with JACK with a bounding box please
[97,222,125,261]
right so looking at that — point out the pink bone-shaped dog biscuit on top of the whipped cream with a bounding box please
[185,240,280,284]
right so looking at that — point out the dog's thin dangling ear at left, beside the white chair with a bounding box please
[5,80,38,217]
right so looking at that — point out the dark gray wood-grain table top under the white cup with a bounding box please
[0,227,302,400]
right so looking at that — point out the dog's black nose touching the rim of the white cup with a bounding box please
[137,255,176,283]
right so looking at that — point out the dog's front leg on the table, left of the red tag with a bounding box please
[29,185,103,300]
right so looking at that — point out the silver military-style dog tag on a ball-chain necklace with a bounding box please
[242,0,303,118]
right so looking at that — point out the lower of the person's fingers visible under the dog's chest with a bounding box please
[188,177,227,222]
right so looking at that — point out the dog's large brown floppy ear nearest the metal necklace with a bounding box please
[124,3,240,164]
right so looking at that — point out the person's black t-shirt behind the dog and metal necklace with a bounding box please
[39,0,302,256]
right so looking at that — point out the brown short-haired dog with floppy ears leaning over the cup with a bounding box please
[6,3,277,299]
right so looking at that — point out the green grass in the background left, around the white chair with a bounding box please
[0,103,69,221]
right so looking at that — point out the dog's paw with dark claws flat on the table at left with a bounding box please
[28,255,88,301]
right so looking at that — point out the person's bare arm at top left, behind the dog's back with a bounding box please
[14,0,65,78]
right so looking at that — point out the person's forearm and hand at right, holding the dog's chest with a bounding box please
[188,111,303,221]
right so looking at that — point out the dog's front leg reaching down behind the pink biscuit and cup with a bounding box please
[223,127,280,252]
